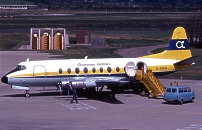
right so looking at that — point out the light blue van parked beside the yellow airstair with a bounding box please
[164,86,195,104]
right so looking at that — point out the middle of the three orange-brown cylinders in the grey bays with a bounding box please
[40,32,49,50]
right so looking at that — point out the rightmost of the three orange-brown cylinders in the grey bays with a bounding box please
[53,32,63,50]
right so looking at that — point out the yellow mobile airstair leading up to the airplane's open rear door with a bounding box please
[135,70,165,98]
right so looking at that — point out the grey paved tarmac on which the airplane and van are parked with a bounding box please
[0,51,202,130]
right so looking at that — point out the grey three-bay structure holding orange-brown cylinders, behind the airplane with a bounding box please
[30,28,69,50]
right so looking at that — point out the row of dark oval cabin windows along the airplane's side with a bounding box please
[59,67,120,74]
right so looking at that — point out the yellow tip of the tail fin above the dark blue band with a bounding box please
[172,27,187,40]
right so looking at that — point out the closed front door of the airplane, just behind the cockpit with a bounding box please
[33,65,46,81]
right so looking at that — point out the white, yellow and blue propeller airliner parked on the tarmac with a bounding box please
[1,27,196,97]
